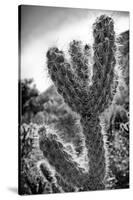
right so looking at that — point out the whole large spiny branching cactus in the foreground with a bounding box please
[40,15,116,191]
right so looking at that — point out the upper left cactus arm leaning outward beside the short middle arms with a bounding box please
[47,48,86,112]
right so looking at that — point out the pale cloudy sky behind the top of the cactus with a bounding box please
[20,5,129,92]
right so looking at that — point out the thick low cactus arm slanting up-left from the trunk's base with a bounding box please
[40,128,88,187]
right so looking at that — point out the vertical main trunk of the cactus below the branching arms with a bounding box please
[81,117,106,190]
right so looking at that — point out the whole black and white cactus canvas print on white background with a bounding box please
[18,5,130,195]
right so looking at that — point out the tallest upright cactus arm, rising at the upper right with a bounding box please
[91,15,116,113]
